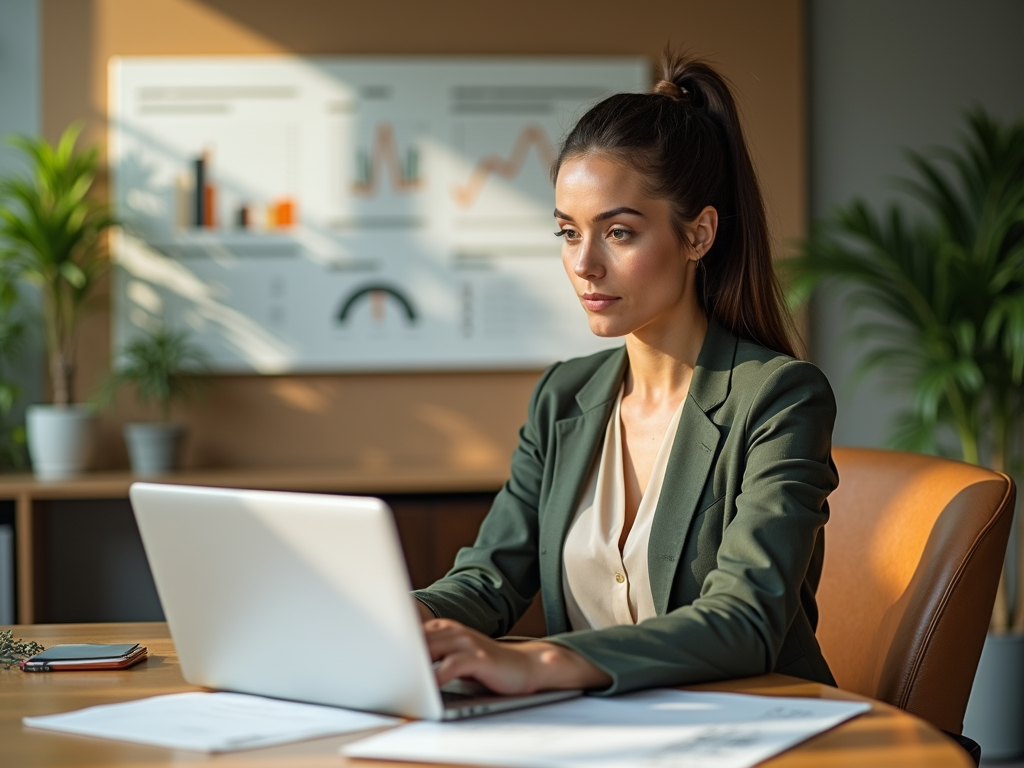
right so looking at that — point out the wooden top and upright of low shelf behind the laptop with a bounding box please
[0,467,507,624]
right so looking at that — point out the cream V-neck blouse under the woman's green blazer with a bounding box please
[562,388,685,630]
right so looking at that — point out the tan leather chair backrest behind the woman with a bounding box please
[817,449,1016,733]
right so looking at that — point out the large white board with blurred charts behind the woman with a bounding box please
[109,57,648,373]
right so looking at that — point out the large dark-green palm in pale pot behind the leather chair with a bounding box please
[783,111,1024,758]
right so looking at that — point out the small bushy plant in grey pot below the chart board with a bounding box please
[100,328,206,475]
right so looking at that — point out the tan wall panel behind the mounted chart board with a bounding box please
[42,0,806,468]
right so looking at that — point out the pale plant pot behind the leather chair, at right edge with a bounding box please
[964,635,1024,760]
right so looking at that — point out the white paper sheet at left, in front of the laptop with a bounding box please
[23,691,401,752]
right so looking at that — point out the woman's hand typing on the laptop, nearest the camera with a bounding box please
[423,618,611,693]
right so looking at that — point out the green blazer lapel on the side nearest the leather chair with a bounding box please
[647,321,736,615]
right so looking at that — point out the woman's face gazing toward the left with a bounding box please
[555,155,714,337]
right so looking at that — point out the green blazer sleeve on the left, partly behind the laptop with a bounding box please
[413,364,559,637]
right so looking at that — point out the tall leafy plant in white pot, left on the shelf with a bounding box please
[0,126,113,479]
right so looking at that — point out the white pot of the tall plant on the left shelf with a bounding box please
[25,406,96,480]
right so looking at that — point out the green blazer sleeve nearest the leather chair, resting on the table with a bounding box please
[548,360,839,694]
